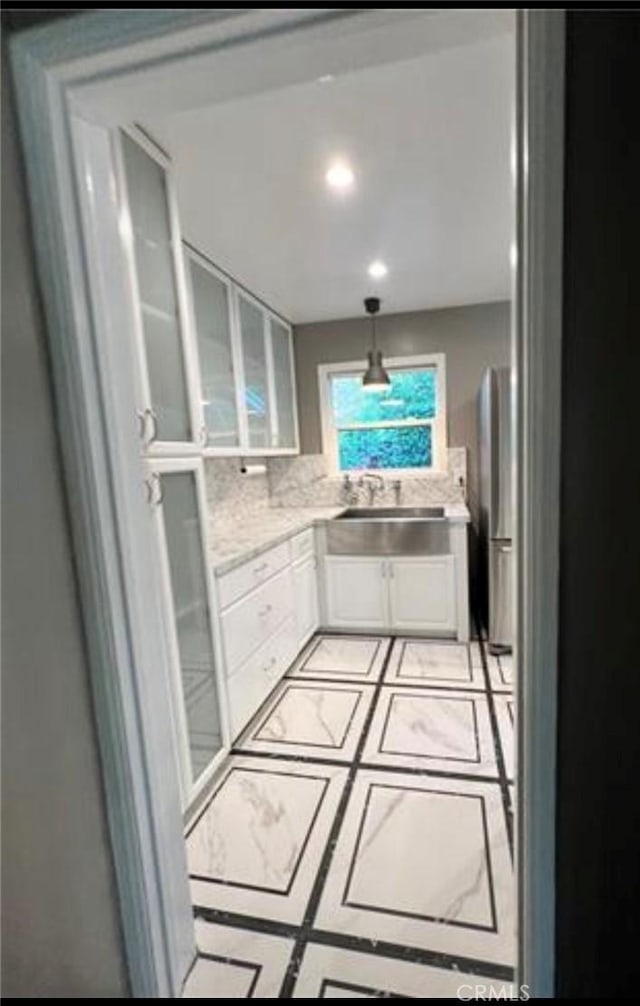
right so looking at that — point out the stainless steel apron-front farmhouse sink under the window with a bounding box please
[326,506,452,555]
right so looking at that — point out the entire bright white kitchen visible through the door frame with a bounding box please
[110,22,515,998]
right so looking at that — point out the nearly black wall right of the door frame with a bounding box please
[556,12,640,998]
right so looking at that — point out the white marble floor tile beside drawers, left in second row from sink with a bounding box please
[236,679,374,759]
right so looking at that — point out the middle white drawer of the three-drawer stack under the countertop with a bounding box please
[221,566,294,674]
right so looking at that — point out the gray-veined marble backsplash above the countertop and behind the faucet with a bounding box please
[204,447,467,520]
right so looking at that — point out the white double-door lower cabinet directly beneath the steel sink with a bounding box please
[325,555,458,635]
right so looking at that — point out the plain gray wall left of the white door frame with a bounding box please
[2,41,128,998]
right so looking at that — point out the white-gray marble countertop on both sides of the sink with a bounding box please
[209,503,471,576]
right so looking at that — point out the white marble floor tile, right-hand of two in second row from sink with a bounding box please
[363,686,497,776]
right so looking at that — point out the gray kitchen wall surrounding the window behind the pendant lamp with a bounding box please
[294,301,510,509]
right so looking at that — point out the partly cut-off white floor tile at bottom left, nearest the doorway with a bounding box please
[183,918,293,999]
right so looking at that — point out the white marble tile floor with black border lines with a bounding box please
[184,634,515,999]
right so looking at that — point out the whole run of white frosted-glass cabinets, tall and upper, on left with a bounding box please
[115,128,298,809]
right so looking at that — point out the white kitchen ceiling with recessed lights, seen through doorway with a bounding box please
[144,24,514,322]
